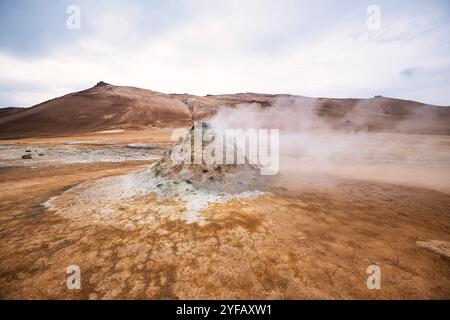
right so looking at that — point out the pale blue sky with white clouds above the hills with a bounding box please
[0,0,450,107]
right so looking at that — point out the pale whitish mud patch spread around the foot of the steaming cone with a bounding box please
[43,170,267,228]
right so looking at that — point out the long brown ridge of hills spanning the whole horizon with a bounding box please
[0,82,450,138]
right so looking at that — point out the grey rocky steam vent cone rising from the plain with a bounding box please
[152,122,268,193]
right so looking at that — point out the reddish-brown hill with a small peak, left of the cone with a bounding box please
[0,82,191,136]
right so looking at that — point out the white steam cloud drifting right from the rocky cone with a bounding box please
[209,97,450,191]
